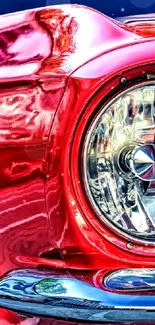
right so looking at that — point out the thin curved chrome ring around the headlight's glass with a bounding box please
[82,81,155,246]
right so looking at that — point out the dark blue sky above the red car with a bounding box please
[0,0,155,17]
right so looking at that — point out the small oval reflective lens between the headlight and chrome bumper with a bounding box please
[104,269,155,292]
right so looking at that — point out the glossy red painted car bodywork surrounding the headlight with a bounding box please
[0,1,155,325]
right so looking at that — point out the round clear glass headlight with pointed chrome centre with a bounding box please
[83,83,155,240]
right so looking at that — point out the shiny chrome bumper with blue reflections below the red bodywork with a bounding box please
[0,270,155,322]
